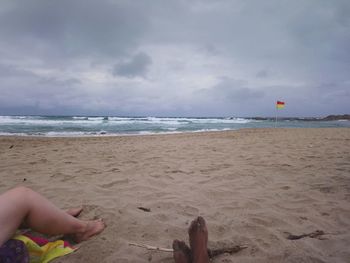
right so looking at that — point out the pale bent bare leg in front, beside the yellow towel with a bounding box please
[0,187,105,245]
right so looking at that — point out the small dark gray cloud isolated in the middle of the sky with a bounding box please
[113,53,152,78]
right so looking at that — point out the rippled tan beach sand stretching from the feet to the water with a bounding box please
[0,128,350,263]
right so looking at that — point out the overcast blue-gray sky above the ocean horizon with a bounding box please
[0,0,350,116]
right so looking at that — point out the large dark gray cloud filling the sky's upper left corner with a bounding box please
[0,0,148,59]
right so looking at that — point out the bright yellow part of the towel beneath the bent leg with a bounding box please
[14,235,74,263]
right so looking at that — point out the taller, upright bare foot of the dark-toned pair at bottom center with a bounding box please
[188,216,209,263]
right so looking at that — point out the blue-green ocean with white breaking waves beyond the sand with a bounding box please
[0,116,350,137]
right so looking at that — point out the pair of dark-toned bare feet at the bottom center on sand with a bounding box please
[173,216,209,263]
